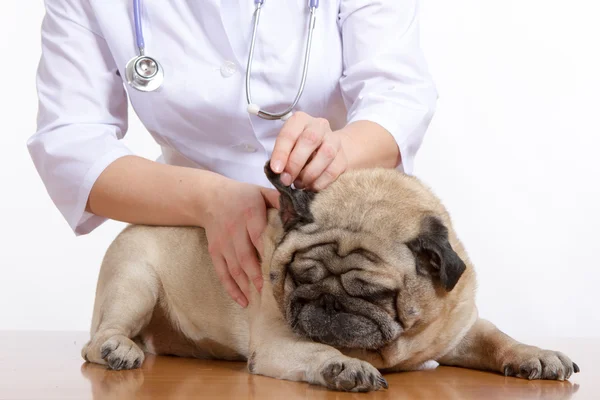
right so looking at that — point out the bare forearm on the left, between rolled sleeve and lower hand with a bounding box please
[87,156,226,226]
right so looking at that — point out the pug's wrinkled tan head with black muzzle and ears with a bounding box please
[265,163,466,350]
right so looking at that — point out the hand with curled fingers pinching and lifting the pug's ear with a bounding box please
[271,112,348,191]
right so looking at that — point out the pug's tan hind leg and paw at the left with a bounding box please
[81,257,160,370]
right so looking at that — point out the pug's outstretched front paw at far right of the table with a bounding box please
[502,345,579,381]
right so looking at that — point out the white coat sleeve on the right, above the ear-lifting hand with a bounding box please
[339,0,438,174]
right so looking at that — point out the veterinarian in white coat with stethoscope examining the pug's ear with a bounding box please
[27,0,437,307]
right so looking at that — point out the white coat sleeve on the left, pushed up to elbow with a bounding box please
[27,0,132,235]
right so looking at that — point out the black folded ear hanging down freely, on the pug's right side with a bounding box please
[406,216,466,292]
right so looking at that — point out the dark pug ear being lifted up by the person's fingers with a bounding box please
[265,160,315,231]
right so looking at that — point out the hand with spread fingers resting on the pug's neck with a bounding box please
[203,178,279,307]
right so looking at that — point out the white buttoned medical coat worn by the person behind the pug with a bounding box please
[27,0,437,235]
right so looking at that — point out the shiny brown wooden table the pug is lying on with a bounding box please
[0,332,600,400]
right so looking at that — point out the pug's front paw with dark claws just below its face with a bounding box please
[321,357,388,392]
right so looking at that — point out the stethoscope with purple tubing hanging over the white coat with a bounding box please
[125,0,319,121]
